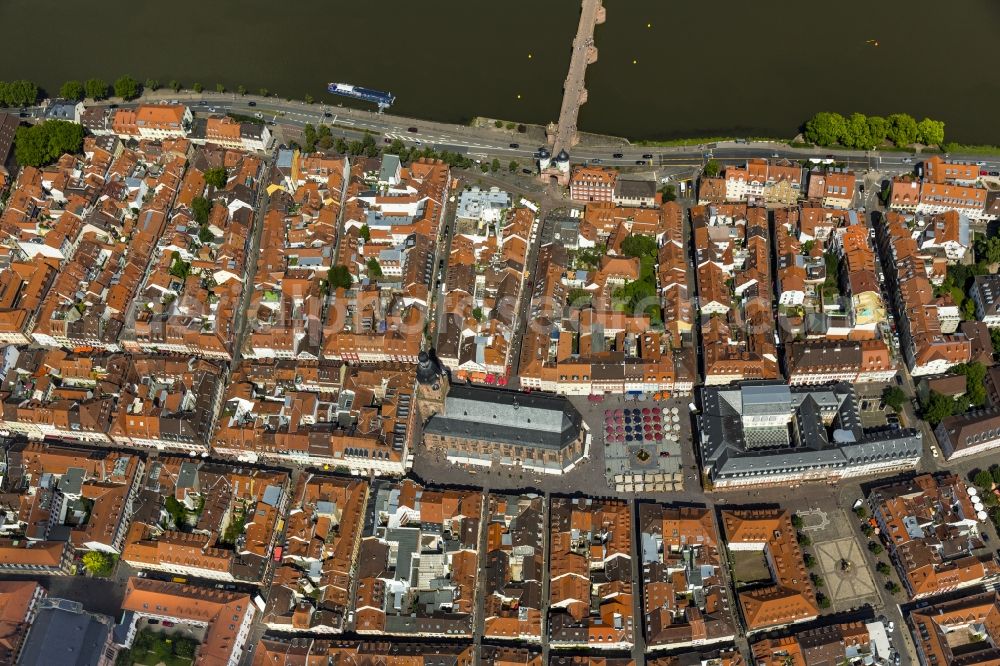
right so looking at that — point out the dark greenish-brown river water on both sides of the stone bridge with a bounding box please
[0,0,1000,144]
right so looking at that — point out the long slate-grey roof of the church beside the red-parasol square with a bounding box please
[424,385,583,449]
